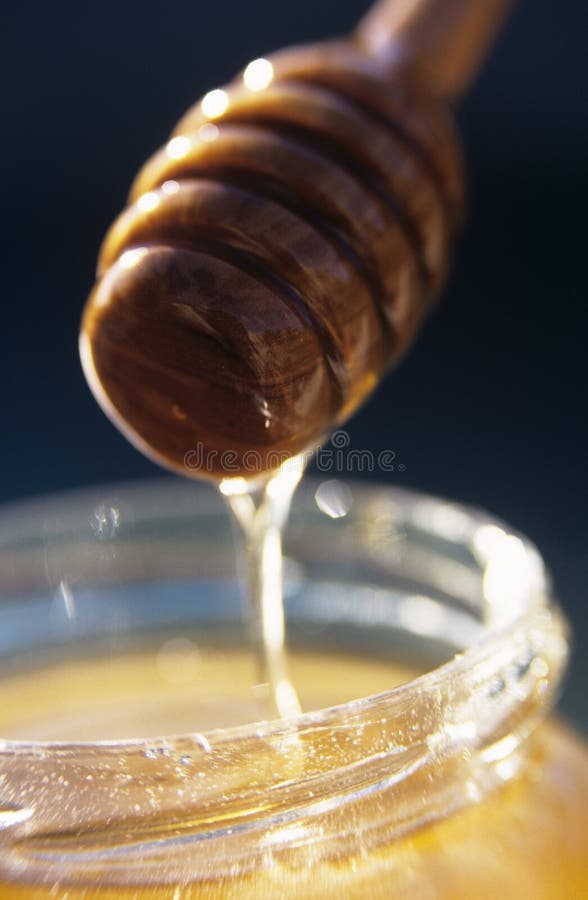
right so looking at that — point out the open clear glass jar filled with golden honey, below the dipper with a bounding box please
[0,481,588,900]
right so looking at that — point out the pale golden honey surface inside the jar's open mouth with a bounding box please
[0,638,417,741]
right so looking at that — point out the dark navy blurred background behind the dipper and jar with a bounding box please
[0,0,588,728]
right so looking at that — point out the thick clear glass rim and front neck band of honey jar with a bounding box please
[0,479,567,880]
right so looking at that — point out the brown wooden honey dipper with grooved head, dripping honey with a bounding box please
[81,0,510,480]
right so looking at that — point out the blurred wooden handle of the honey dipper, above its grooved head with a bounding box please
[356,0,513,99]
